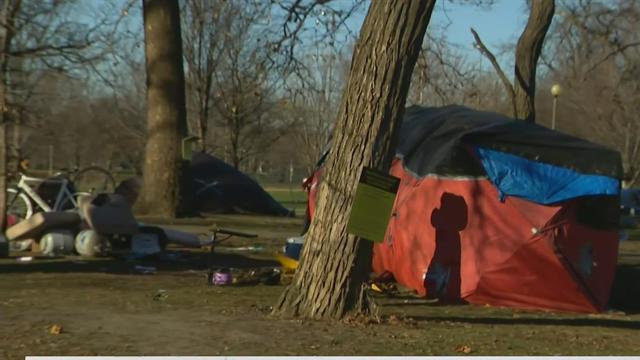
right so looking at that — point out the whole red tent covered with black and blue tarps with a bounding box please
[310,107,621,312]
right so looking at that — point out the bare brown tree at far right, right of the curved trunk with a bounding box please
[543,0,640,187]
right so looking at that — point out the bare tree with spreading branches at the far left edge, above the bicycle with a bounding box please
[0,0,127,229]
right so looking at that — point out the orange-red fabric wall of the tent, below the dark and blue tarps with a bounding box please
[373,161,617,312]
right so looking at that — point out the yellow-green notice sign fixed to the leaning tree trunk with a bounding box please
[347,167,400,242]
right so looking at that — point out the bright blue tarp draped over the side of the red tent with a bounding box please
[476,147,620,205]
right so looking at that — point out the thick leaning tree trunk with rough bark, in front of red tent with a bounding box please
[275,0,435,318]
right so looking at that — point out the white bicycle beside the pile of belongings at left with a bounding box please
[7,166,116,222]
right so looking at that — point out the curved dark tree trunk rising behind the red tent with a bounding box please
[514,0,555,122]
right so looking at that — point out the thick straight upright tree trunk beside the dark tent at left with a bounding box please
[136,0,187,217]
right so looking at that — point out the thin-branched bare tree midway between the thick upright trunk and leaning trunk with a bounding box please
[213,2,287,168]
